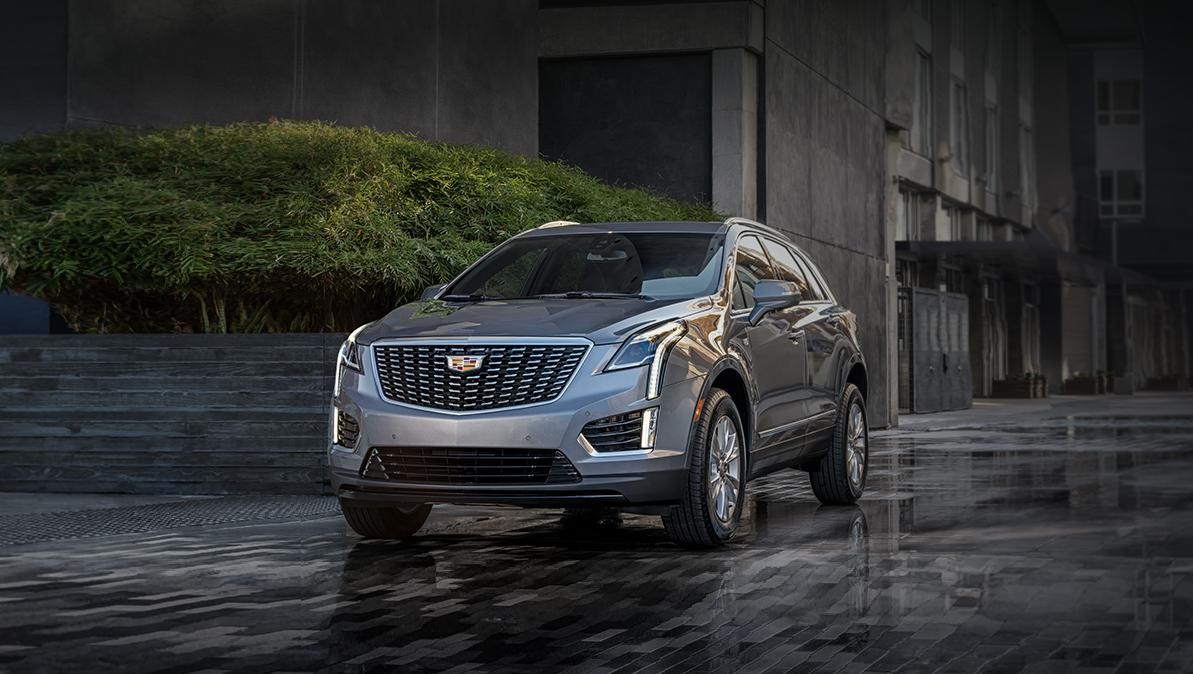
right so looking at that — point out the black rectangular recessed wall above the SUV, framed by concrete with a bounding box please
[538,54,712,202]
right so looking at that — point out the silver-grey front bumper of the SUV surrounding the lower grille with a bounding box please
[328,345,703,507]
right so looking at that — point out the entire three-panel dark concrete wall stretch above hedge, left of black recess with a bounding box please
[60,0,538,154]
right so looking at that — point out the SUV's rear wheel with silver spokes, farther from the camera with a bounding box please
[808,384,870,506]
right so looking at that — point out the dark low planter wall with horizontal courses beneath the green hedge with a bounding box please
[0,334,342,494]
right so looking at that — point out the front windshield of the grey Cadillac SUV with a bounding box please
[441,233,723,299]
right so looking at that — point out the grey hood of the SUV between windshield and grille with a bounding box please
[357,297,711,344]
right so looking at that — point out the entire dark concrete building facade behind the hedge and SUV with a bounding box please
[0,0,1189,426]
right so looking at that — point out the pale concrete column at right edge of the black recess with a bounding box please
[712,49,758,218]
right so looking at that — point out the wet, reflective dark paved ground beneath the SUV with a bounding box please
[0,396,1193,672]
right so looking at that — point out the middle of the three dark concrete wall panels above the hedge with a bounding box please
[299,0,438,138]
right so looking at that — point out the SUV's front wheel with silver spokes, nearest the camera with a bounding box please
[663,389,746,548]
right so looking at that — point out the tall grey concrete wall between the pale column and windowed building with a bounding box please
[764,2,891,426]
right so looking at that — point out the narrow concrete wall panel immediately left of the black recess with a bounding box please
[437,0,538,155]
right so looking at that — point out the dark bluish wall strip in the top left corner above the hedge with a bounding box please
[0,0,67,141]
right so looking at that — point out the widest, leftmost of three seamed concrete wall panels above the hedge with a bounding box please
[67,0,299,126]
